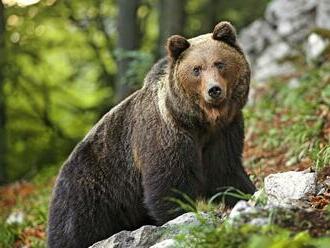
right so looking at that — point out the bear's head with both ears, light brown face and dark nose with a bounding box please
[167,22,250,128]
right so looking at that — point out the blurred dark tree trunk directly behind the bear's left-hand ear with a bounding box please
[158,0,186,57]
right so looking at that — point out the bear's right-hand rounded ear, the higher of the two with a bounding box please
[212,22,236,45]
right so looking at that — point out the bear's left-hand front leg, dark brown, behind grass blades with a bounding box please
[142,136,203,225]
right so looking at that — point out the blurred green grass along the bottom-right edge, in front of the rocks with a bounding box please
[176,217,330,248]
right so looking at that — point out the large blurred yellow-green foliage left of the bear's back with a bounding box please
[5,1,112,180]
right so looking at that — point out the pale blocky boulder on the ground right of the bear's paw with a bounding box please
[264,171,316,207]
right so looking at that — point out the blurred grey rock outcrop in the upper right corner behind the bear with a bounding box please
[239,0,330,82]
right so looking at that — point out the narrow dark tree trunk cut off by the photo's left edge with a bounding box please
[0,1,7,185]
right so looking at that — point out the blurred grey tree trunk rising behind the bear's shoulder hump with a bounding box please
[116,0,141,102]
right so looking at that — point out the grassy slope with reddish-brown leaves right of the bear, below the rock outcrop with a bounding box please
[245,64,330,170]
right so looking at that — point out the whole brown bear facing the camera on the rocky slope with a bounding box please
[48,22,255,248]
